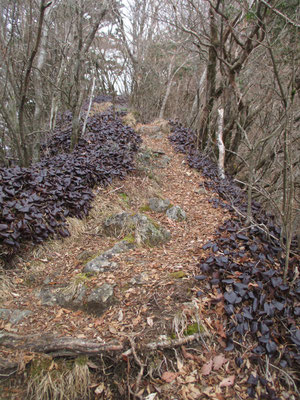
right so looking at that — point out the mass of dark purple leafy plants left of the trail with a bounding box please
[0,111,141,255]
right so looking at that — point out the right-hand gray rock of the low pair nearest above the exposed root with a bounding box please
[85,283,116,315]
